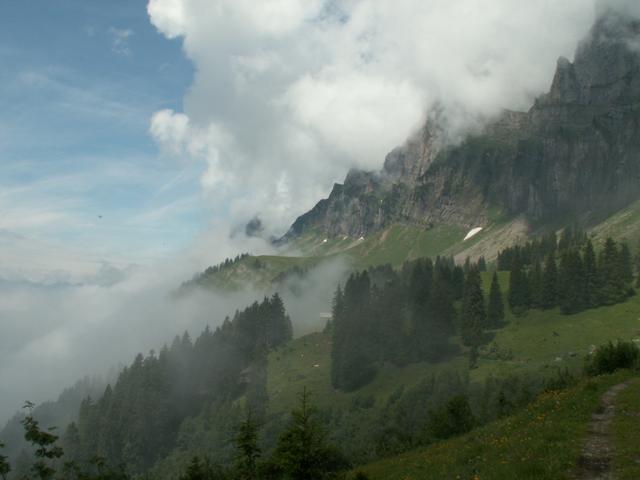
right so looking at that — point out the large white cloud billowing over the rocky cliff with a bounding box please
[148,0,608,231]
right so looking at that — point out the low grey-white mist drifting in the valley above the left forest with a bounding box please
[0,230,347,425]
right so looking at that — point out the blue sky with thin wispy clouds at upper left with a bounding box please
[0,0,206,276]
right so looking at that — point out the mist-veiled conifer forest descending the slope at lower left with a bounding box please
[52,294,292,478]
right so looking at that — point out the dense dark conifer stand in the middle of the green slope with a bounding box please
[329,258,475,391]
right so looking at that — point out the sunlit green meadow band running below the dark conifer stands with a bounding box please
[267,273,640,413]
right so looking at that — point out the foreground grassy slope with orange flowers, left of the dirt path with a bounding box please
[361,371,638,480]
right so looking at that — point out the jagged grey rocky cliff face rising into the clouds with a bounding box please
[287,11,640,242]
